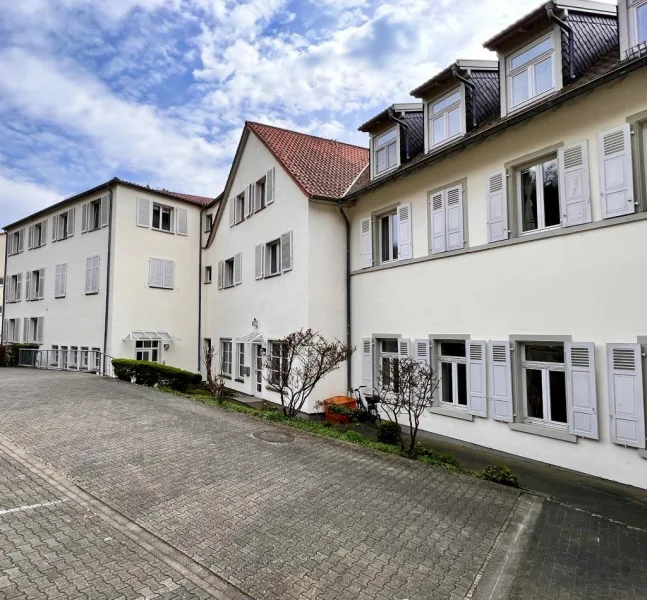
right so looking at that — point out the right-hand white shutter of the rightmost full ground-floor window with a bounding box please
[564,342,598,440]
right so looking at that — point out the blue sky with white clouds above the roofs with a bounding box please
[0,0,616,226]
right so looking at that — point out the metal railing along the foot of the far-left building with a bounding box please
[18,348,115,377]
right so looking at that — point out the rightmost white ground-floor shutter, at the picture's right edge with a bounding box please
[607,344,645,448]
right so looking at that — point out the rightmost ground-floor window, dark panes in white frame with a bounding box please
[521,344,568,428]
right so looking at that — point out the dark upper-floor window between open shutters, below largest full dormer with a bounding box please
[517,157,561,233]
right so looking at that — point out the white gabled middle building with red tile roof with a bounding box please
[202,123,368,413]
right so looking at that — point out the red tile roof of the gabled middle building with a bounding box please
[246,121,368,198]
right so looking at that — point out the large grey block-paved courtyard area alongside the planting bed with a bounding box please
[0,369,518,600]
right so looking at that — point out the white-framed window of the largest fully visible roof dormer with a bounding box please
[507,36,555,108]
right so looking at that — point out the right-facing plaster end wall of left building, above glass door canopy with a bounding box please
[107,186,201,372]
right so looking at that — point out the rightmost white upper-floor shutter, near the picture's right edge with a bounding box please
[598,123,636,219]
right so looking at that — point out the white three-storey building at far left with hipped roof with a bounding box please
[3,178,213,371]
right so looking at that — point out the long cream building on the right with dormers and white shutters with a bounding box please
[345,0,647,487]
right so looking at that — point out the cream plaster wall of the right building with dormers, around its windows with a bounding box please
[352,73,647,488]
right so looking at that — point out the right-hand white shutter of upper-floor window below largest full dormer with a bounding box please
[559,140,591,227]
